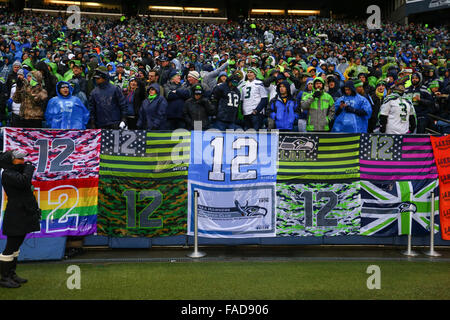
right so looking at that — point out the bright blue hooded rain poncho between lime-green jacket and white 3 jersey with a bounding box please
[331,81,372,133]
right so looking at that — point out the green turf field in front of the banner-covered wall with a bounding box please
[0,261,450,300]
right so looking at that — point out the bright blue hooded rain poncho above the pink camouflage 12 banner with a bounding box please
[45,81,89,129]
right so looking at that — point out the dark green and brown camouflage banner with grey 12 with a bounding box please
[97,177,188,237]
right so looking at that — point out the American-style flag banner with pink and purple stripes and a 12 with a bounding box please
[359,134,438,181]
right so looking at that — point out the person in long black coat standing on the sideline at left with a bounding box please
[0,150,41,288]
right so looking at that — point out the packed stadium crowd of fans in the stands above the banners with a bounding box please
[0,12,450,134]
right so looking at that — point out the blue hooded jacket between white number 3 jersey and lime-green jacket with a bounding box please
[270,81,299,130]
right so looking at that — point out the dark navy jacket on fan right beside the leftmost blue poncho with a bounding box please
[89,80,127,128]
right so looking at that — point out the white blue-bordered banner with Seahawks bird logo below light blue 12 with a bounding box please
[188,182,276,238]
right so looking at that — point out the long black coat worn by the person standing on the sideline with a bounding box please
[2,164,40,236]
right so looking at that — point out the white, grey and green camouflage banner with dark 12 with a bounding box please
[277,182,361,236]
